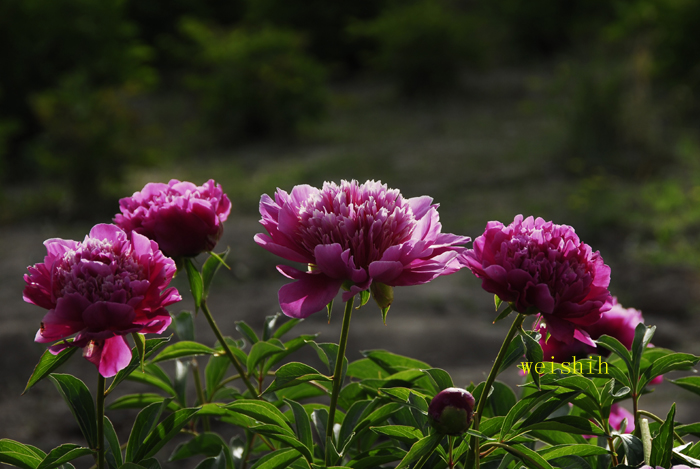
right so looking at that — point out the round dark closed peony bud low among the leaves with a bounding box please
[428,388,474,435]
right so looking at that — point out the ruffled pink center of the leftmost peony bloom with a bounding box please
[54,238,145,302]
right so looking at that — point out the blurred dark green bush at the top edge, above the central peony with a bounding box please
[350,0,477,95]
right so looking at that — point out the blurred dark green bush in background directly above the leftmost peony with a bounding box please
[25,74,152,215]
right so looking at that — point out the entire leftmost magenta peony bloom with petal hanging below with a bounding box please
[24,224,182,378]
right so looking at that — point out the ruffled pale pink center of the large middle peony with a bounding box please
[298,181,416,268]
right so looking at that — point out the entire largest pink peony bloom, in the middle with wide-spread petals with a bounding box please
[255,180,470,318]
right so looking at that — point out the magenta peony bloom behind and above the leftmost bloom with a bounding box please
[114,179,231,257]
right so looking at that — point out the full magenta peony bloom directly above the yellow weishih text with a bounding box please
[462,215,612,345]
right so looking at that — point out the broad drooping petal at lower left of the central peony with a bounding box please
[279,273,343,318]
